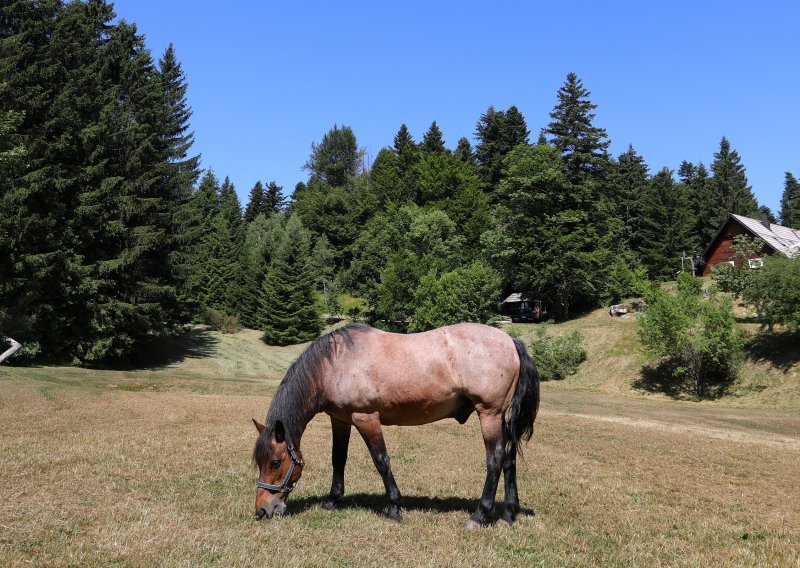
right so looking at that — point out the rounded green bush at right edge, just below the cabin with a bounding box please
[742,255,800,331]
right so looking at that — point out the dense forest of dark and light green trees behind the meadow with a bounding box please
[0,0,800,364]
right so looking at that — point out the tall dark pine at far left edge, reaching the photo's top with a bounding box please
[0,0,85,359]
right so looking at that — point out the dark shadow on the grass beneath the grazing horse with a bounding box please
[289,493,535,516]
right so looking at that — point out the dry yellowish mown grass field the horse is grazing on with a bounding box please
[0,318,800,566]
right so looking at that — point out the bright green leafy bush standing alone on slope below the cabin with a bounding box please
[639,279,743,398]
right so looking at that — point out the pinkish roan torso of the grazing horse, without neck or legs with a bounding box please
[325,323,519,424]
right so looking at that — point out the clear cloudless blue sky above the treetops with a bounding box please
[109,0,800,214]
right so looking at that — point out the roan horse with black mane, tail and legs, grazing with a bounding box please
[253,323,539,529]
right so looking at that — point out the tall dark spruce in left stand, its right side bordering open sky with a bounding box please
[76,21,180,361]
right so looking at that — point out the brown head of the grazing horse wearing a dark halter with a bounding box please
[253,418,303,519]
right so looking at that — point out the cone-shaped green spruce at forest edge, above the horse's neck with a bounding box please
[259,215,322,345]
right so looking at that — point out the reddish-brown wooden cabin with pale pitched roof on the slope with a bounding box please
[703,215,800,276]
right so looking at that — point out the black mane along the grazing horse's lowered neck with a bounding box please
[253,323,373,464]
